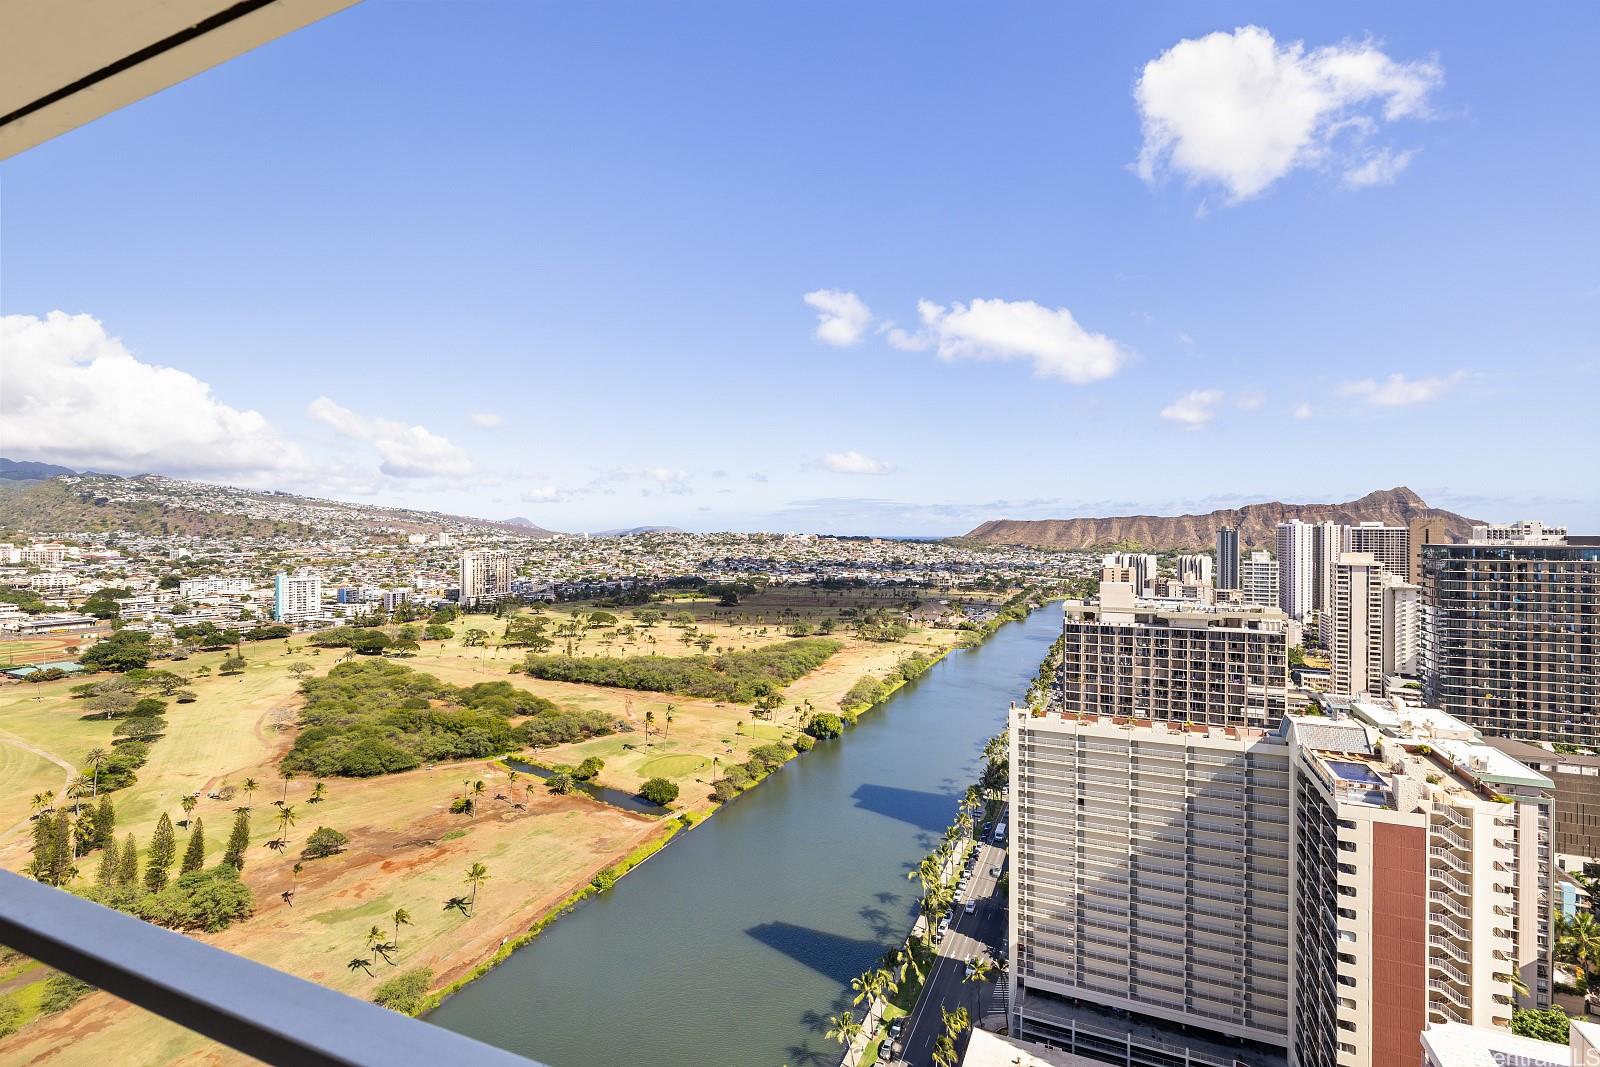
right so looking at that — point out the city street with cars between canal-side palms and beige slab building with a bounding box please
[883,805,1010,1067]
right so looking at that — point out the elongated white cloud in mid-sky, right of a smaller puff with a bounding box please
[915,299,1128,386]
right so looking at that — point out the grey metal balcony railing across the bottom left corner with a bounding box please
[0,870,538,1067]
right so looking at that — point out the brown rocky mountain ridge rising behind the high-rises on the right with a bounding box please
[963,486,1482,550]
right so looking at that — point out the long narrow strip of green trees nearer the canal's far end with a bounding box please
[523,638,840,702]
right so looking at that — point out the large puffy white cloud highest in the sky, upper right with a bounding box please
[1133,26,1443,203]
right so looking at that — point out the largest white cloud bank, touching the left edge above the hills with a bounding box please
[0,310,309,483]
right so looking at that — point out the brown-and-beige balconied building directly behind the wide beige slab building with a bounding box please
[1061,582,1290,728]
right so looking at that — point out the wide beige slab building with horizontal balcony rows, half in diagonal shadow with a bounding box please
[1010,710,1291,1064]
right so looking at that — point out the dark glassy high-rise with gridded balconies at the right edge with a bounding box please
[1421,523,1600,745]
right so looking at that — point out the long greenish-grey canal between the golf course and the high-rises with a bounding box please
[429,605,1061,1067]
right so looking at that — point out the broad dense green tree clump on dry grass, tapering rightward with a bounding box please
[282,659,619,777]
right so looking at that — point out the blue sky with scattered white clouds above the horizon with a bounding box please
[0,0,1600,534]
